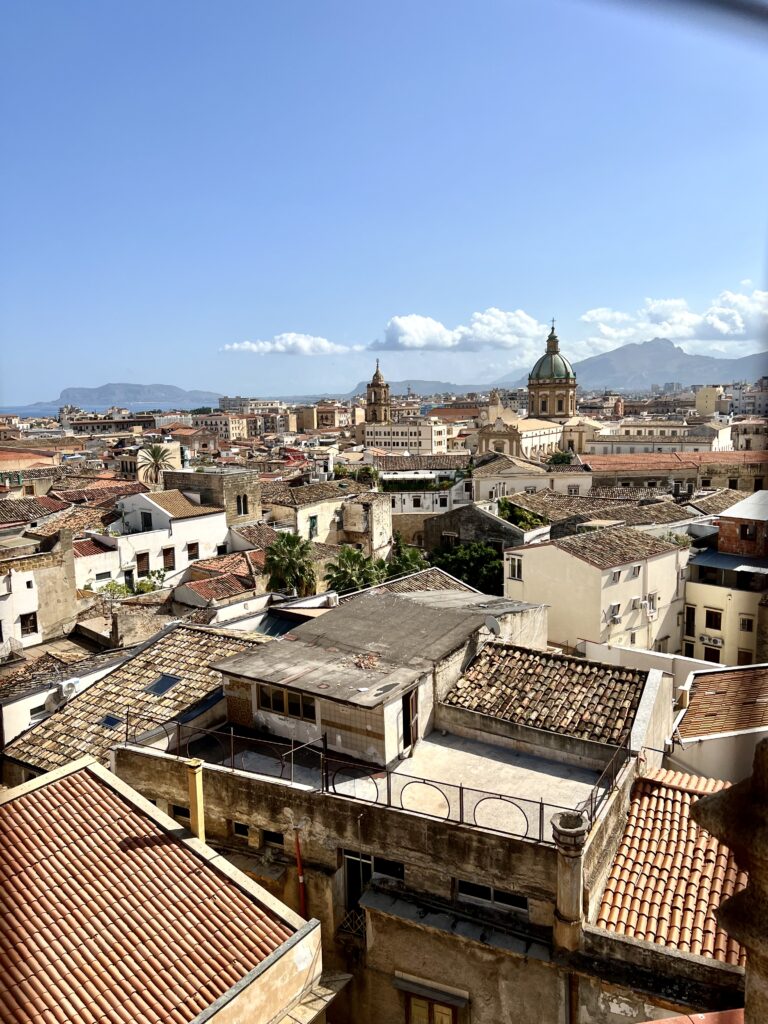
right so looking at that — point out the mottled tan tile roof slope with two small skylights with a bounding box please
[5,626,268,771]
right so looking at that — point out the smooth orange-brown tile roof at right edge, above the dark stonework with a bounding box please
[679,665,768,739]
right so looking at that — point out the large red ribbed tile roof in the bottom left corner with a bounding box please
[0,767,296,1024]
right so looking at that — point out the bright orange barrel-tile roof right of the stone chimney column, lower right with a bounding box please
[596,770,746,967]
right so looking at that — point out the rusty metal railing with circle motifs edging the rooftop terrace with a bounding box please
[125,713,629,846]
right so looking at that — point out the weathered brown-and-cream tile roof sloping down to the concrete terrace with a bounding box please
[444,643,647,745]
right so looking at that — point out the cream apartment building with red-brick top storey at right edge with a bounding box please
[683,490,768,666]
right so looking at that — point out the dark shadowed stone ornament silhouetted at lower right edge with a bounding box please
[691,739,768,1024]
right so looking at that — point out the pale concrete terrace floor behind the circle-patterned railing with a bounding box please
[204,732,599,843]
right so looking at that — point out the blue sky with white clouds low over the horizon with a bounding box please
[0,0,768,404]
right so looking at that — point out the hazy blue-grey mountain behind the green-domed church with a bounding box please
[496,338,768,391]
